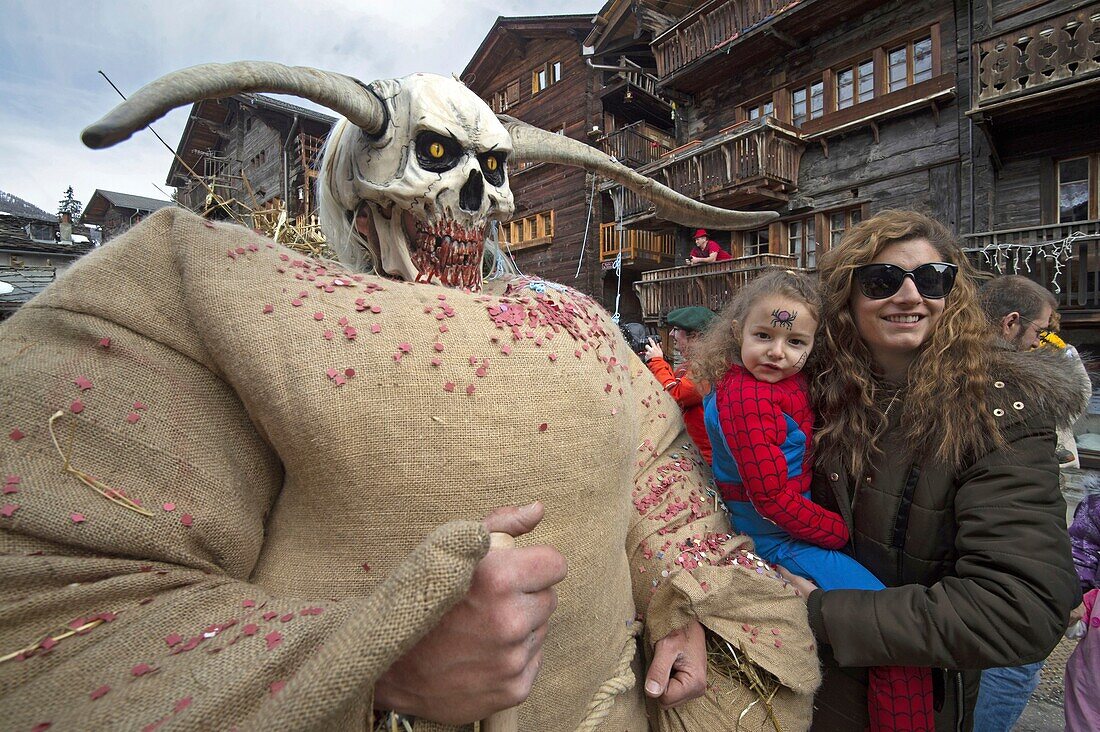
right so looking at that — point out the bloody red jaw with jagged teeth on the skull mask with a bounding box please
[409,220,485,291]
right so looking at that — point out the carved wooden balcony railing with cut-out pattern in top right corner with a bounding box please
[972,3,1100,108]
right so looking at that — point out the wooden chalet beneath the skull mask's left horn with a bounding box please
[167,94,336,241]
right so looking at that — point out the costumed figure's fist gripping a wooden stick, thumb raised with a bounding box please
[374,503,565,724]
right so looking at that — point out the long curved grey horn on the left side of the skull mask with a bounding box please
[80,61,387,150]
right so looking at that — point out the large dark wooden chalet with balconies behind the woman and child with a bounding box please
[585,0,1100,343]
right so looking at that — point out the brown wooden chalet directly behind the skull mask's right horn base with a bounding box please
[461,14,616,308]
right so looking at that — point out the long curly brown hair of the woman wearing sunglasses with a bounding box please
[813,210,1003,479]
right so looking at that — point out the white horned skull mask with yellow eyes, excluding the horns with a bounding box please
[327,74,514,289]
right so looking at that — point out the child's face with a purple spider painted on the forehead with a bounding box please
[741,295,817,384]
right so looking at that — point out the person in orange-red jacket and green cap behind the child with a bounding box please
[642,303,717,465]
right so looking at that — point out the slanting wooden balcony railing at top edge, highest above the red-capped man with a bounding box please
[653,0,799,79]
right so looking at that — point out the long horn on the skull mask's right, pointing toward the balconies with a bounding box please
[497,114,779,231]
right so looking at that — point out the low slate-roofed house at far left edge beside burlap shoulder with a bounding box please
[0,211,95,320]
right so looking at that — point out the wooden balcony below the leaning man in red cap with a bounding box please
[634,254,798,324]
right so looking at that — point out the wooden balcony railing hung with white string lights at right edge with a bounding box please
[963,220,1100,310]
